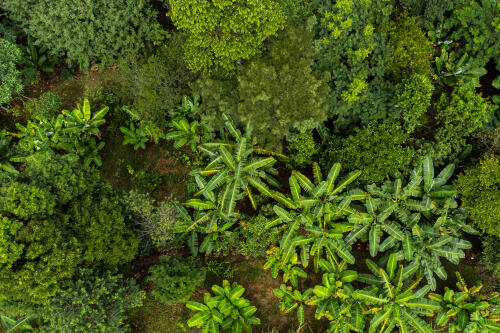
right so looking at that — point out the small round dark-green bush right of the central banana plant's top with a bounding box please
[287,131,319,168]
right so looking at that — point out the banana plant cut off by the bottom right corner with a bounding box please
[428,272,500,333]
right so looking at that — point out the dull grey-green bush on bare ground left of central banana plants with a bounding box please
[125,190,177,251]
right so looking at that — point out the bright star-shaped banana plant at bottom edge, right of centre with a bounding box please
[353,254,441,333]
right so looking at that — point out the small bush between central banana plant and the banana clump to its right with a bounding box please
[238,214,280,258]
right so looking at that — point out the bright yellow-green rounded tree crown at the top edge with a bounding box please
[168,0,285,72]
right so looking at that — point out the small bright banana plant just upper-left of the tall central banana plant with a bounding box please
[165,118,201,152]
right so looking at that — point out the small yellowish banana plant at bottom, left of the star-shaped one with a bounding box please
[307,257,365,332]
